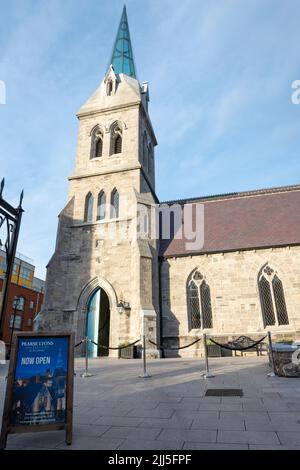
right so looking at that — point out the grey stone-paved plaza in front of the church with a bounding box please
[0,356,300,450]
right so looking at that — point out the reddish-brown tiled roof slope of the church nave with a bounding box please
[160,185,300,256]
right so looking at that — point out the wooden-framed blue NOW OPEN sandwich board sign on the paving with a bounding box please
[0,332,74,449]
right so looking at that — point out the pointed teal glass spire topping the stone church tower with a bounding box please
[109,5,136,78]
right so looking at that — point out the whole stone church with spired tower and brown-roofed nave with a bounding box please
[36,7,300,357]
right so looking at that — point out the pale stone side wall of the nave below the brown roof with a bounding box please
[161,246,300,357]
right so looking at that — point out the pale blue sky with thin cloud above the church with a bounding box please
[0,0,300,277]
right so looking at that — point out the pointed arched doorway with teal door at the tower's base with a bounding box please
[86,287,110,357]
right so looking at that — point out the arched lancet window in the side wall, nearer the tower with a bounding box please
[187,271,213,329]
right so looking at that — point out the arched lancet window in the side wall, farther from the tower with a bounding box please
[258,266,289,327]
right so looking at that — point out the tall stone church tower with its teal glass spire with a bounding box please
[37,7,159,357]
